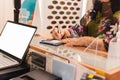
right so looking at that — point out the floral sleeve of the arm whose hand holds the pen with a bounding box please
[69,11,91,37]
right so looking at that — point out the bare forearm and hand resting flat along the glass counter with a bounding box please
[61,36,106,51]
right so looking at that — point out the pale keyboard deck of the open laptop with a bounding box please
[0,54,18,69]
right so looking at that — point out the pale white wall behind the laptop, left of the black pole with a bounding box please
[0,0,14,32]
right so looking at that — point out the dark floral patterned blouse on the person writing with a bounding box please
[69,2,118,50]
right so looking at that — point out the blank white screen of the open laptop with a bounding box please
[0,21,36,59]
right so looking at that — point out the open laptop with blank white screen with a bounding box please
[0,21,37,70]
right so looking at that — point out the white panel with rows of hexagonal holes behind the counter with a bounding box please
[39,0,82,33]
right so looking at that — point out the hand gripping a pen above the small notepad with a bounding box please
[52,28,70,40]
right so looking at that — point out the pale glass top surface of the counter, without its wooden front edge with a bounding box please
[31,36,120,71]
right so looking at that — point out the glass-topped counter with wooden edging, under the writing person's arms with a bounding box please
[30,34,120,80]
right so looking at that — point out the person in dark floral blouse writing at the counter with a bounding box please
[51,0,120,51]
